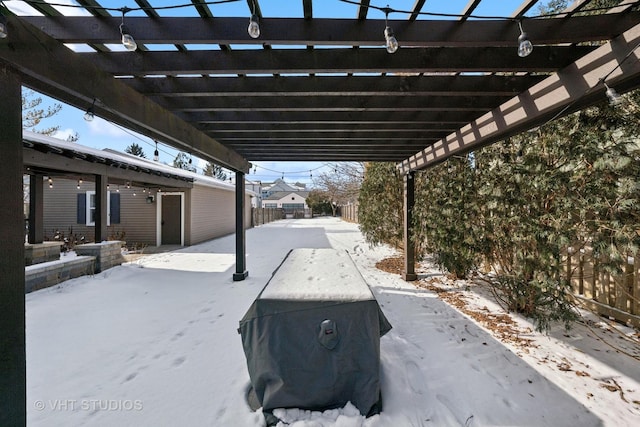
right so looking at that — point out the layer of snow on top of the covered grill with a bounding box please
[260,248,373,301]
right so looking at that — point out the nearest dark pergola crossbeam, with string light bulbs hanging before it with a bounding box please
[21,12,640,47]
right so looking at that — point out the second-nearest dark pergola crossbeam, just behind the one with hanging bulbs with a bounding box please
[81,46,595,76]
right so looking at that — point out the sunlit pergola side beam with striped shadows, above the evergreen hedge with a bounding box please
[398,24,640,173]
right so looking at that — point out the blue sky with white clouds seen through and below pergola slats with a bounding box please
[12,0,545,184]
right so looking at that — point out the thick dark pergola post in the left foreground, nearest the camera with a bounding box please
[0,64,27,426]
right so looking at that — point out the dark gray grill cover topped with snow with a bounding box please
[239,249,391,416]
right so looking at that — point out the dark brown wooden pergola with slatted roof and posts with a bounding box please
[0,0,640,425]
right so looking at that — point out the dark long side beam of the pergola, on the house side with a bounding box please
[0,17,249,171]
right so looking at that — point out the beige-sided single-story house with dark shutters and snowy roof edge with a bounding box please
[24,132,256,246]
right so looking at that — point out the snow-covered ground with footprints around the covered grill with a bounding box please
[26,218,640,427]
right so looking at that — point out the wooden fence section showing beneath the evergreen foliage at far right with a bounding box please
[564,249,640,327]
